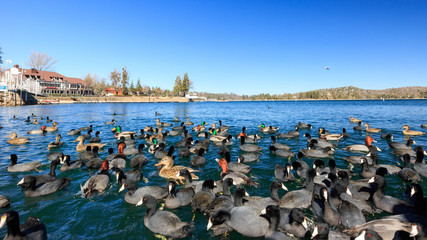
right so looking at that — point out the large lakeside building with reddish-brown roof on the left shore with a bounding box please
[0,65,93,95]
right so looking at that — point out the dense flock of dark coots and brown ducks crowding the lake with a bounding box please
[0,112,427,239]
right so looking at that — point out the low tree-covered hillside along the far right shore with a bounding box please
[197,86,427,100]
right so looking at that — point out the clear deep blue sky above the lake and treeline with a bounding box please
[0,0,427,94]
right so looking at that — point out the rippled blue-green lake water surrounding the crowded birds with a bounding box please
[0,100,427,239]
